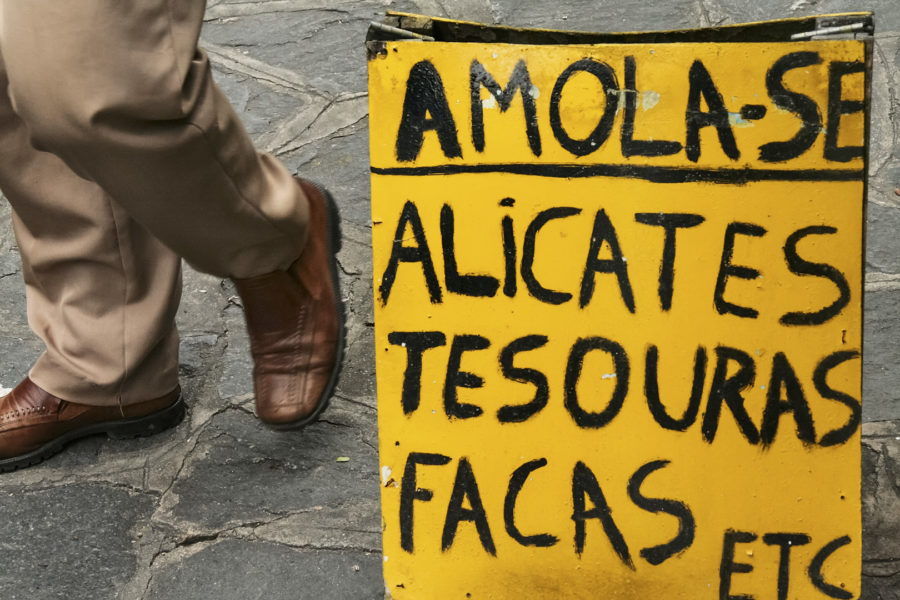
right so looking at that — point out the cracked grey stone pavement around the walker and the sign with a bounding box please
[0,0,900,600]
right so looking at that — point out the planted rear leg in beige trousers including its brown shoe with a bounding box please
[0,51,183,472]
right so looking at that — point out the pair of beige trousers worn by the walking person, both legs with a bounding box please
[0,0,308,404]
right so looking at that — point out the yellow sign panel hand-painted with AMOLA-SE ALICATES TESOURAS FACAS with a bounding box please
[369,17,866,600]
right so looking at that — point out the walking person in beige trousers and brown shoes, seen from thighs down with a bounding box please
[0,0,344,472]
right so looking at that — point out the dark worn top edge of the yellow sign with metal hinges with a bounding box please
[366,12,874,47]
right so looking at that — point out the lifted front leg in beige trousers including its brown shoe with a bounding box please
[0,0,343,426]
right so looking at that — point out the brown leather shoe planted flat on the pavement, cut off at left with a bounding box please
[0,378,184,473]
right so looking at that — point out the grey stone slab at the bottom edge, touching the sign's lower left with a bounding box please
[145,539,383,600]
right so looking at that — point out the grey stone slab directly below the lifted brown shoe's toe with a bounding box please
[155,402,378,535]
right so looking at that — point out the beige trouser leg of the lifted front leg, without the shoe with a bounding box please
[0,0,309,278]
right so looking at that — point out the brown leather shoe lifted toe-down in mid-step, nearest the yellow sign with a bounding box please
[234,178,344,429]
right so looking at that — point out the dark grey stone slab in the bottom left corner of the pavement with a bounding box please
[0,484,154,600]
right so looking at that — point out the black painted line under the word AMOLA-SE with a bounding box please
[371,163,864,185]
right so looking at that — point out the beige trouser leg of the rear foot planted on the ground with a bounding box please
[0,59,181,404]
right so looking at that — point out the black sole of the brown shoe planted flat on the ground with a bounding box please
[0,396,186,473]
